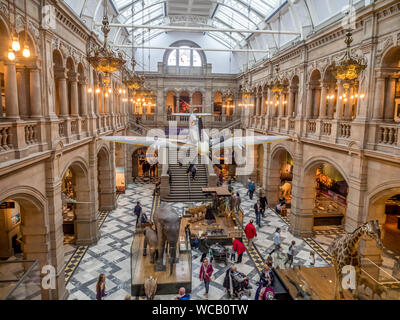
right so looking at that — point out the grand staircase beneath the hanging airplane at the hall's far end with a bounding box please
[162,148,208,202]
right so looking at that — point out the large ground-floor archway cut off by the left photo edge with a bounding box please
[0,193,50,300]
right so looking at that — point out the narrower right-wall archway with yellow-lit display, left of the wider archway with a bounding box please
[268,148,294,209]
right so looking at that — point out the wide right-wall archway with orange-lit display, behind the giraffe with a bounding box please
[303,162,349,227]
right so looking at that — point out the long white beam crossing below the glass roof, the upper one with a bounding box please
[96,23,300,35]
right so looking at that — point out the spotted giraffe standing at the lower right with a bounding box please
[329,220,383,299]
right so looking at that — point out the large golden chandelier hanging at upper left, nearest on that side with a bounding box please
[88,0,126,86]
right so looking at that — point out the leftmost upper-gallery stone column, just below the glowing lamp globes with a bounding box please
[4,61,20,120]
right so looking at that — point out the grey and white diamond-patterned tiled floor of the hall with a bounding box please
[67,182,326,300]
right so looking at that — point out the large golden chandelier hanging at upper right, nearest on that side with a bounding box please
[332,29,367,90]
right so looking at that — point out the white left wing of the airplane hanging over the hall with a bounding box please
[101,136,188,147]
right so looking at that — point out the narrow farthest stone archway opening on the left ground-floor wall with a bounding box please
[97,145,116,211]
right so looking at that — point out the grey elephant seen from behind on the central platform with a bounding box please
[153,203,181,275]
